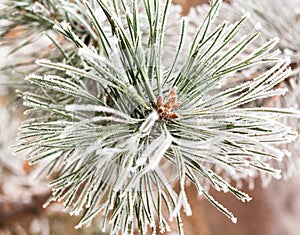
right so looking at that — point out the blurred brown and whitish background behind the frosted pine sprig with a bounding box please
[0,0,300,235]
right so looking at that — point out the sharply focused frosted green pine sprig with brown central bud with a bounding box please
[0,0,300,235]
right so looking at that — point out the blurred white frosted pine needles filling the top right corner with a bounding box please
[233,0,300,61]
